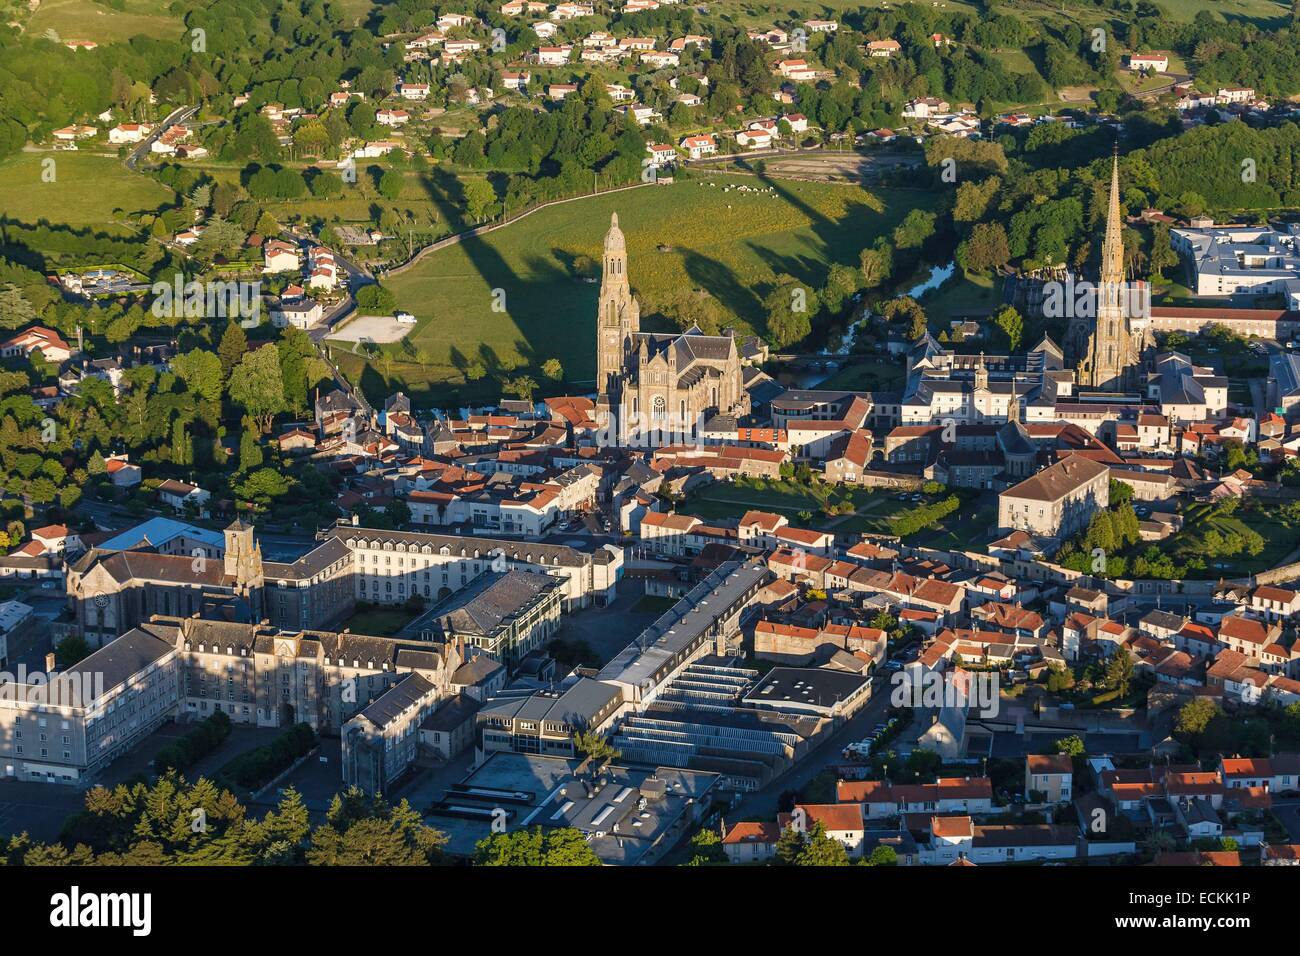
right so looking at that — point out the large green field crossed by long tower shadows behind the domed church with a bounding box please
[358,176,933,402]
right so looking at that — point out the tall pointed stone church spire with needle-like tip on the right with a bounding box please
[1070,148,1149,390]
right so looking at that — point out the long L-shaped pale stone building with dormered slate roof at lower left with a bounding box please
[0,615,464,784]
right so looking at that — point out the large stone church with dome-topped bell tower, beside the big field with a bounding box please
[595,213,750,445]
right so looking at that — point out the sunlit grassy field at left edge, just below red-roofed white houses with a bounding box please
[0,152,173,232]
